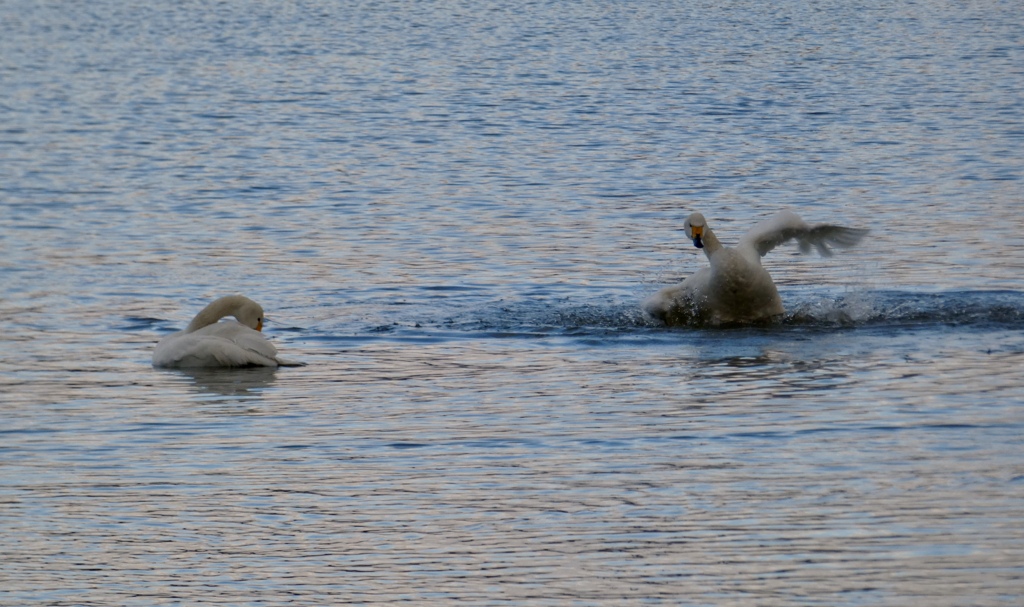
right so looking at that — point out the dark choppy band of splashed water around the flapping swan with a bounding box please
[245,291,1024,341]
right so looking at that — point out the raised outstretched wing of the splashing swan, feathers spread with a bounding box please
[738,211,867,257]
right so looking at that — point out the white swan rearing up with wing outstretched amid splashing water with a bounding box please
[643,211,867,324]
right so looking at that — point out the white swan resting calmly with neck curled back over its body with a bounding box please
[153,295,302,367]
